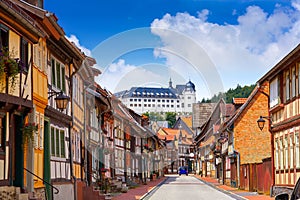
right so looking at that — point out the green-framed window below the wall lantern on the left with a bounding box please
[50,126,66,158]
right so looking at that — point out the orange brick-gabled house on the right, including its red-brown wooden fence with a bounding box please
[218,85,272,193]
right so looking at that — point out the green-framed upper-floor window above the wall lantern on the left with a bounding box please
[51,58,66,92]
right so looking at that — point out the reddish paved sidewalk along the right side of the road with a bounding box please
[194,175,275,200]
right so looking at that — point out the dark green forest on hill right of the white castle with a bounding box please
[201,84,255,103]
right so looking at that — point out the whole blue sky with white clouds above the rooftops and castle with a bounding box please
[45,0,300,100]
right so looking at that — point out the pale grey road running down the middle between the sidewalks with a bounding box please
[144,175,234,200]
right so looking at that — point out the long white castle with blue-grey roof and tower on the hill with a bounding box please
[115,81,196,114]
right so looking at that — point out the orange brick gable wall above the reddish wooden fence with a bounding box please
[234,87,271,164]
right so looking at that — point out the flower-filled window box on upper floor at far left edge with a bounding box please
[0,48,19,90]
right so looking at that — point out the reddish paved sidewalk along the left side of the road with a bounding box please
[112,177,166,200]
